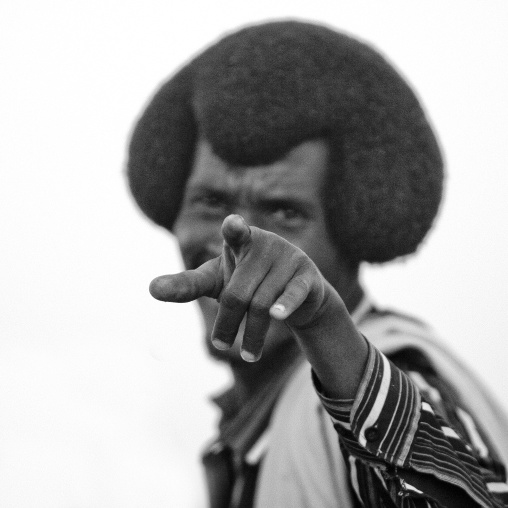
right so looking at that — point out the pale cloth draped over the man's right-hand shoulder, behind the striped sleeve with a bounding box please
[358,306,508,463]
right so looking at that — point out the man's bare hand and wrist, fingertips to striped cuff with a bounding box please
[150,215,368,397]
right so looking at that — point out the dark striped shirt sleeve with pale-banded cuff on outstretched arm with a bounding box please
[313,343,508,507]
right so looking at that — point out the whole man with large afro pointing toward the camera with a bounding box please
[128,22,508,507]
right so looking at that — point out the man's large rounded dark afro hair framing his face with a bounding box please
[127,21,443,263]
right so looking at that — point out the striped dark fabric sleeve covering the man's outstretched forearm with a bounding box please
[315,345,504,507]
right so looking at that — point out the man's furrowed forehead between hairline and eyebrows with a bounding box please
[187,139,328,197]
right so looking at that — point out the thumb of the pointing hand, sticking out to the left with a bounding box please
[149,257,222,303]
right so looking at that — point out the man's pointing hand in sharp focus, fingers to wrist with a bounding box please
[150,215,330,361]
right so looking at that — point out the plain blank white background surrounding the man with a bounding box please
[0,0,508,508]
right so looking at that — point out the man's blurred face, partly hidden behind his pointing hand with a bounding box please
[174,140,344,364]
